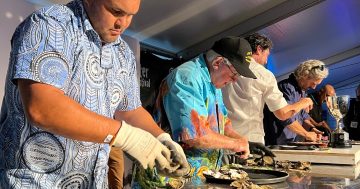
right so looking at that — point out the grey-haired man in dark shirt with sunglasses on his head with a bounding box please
[264,60,329,144]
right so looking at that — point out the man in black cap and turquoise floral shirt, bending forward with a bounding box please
[134,37,274,187]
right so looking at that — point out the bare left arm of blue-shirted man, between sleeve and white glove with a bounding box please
[18,80,120,143]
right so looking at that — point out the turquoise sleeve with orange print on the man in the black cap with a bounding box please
[163,70,210,141]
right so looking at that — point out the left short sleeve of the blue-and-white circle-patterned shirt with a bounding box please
[10,10,76,89]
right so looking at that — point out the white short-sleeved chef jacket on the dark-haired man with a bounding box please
[222,59,287,143]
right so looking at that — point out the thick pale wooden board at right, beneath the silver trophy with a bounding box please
[272,145,360,165]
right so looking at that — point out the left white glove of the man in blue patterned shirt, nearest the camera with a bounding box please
[112,121,171,169]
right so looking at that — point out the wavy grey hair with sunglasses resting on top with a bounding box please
[294,60,329,79]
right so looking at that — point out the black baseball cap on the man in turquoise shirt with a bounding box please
[211,36,256,79]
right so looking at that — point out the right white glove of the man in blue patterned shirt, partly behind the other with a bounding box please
[157,133,190,177]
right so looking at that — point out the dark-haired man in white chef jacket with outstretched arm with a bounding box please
[222,33,313,144]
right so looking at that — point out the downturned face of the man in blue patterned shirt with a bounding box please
[85,0,140,43]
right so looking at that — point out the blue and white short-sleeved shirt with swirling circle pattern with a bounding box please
[0,0,141,188]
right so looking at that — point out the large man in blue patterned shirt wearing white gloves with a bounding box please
[0,0,187,188]
